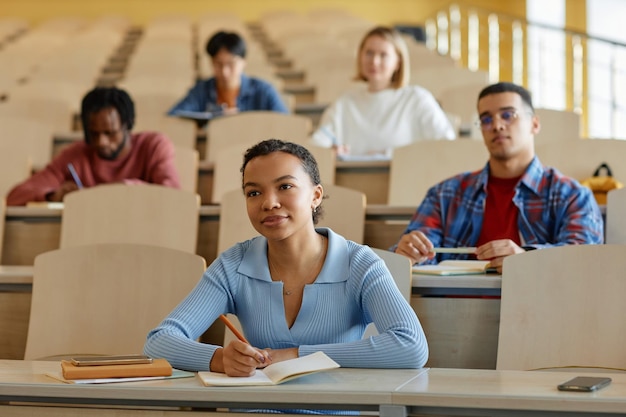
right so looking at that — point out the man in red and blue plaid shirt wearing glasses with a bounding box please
[393,82,604,272]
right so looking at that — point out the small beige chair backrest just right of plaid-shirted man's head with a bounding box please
[535,109,581,144]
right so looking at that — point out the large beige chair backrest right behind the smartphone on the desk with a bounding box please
[496,245,626,370]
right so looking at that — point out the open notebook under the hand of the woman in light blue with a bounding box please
[198,352,339,386]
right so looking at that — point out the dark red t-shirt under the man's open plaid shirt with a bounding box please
[476,175,521,246]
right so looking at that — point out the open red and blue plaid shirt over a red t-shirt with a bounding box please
[404,157,604,263]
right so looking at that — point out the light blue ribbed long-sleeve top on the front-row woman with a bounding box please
[144,228,428,371]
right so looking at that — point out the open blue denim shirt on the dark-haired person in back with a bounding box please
[167,75,289,116]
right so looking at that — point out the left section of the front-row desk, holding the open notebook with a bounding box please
[0,361,424,416]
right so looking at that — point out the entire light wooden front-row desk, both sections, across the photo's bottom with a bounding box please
[0,361,626,417]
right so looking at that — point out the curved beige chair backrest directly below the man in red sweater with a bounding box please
[60,184,200,253]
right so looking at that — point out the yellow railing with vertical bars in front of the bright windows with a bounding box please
[425,3,626,139]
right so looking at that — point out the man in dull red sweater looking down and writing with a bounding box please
[7,87,180,206]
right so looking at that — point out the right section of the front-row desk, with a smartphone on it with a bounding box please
[388,369,626,417]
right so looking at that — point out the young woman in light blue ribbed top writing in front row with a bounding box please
[145,139,428,376]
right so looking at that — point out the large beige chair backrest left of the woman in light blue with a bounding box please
[25,244,206,360]
